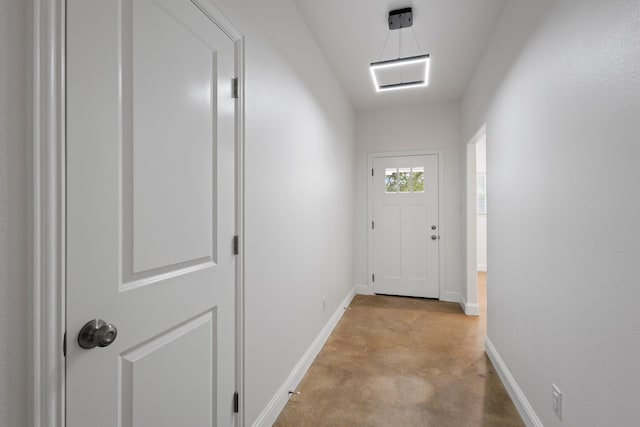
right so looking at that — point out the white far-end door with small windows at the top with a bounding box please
[371,155,440,298]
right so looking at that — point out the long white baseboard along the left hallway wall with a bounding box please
[252,286,356,427]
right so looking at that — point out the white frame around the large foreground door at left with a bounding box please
[28,0,245,427]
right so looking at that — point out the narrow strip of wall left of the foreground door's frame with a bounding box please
[0,0,31,426]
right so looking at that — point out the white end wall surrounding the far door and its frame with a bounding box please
[354,104,463,302]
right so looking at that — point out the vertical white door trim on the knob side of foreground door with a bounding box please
[29,0,65,427]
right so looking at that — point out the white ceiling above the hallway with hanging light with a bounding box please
[294,0,507,110]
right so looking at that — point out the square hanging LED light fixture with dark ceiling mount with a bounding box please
[369,7,430,92]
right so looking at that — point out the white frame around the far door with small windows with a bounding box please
[366,150,447,301]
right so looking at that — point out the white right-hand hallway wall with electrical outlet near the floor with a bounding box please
[462,0,640,427]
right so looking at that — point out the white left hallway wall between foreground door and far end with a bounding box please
[215,0,355,425]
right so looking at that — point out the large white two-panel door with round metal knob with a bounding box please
[66,0,236,427]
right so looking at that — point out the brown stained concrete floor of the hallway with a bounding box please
[274,273,524,427]
